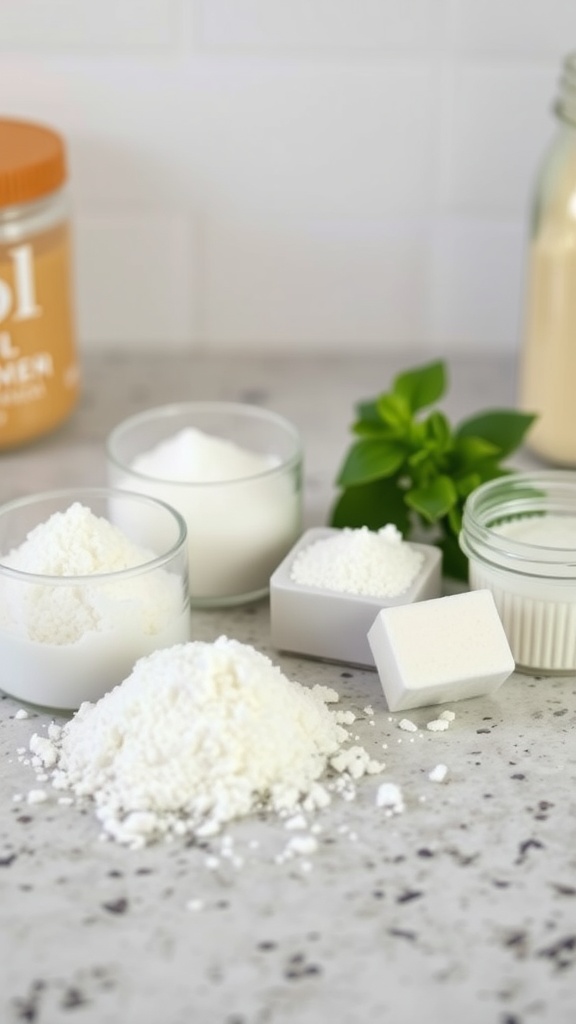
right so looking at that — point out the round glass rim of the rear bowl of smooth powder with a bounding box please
[106,400,303,489]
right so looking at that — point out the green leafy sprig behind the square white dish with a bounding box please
[330,360,535,580]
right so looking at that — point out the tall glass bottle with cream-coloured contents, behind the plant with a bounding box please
[520,52,576,466]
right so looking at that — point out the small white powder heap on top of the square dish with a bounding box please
[290,523,423,597]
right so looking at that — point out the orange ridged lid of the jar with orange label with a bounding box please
[0,119,67,207]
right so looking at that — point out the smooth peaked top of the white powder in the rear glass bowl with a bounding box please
[131,427,278,483]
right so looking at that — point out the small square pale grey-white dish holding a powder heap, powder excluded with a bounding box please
[270,526,442,669]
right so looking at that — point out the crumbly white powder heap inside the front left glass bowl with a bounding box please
[0,502,182,645]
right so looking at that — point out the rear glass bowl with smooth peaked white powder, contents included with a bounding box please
[107,401,302,607]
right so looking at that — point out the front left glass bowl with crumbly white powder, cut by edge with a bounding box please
[0,487,190,710]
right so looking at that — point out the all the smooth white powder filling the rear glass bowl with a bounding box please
[121,427,300,603]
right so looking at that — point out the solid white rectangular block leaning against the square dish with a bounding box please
[368,590,515,711]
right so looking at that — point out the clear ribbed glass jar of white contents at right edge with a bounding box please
[460,469,576,676]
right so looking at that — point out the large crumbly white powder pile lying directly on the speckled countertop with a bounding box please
[30,636,383,848]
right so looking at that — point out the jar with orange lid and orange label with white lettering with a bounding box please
[0,119,80,452]
